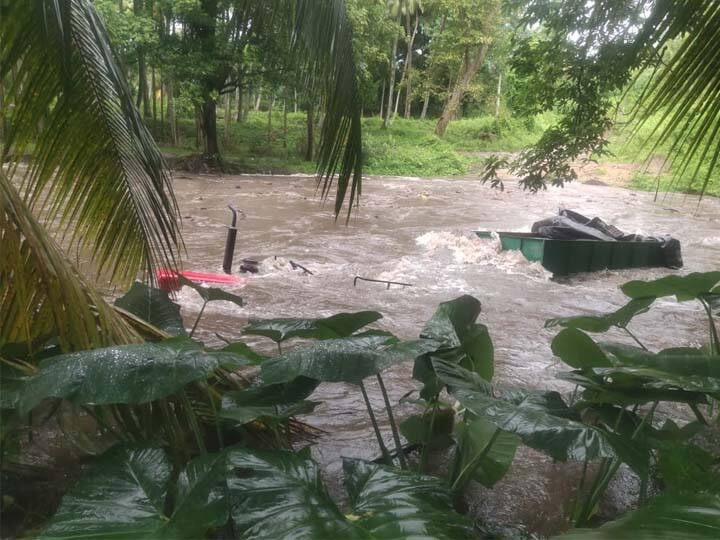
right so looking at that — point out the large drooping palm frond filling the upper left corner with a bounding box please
[0,0,182,283]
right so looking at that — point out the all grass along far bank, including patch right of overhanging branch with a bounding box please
[159,112,720,196]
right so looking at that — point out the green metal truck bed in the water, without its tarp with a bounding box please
[475,231,665,276]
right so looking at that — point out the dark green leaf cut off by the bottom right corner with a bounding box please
[559,493,720,540]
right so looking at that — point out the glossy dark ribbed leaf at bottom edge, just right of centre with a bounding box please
[343,459,475,539]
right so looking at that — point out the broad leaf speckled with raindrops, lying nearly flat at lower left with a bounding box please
[19,339,240,414]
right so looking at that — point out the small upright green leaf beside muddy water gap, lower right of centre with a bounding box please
[451,418,520,487]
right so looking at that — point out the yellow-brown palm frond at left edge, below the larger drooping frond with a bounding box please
[0,171,140,352]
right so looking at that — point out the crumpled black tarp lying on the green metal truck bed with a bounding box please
[532,209,683,268]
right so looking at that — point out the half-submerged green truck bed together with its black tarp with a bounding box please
[474,210,683,276]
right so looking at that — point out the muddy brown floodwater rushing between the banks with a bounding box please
[175,173,720,533]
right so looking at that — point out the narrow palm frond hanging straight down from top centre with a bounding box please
[293,0,362,219]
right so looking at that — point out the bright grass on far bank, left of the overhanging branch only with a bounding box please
[158,111,549,177]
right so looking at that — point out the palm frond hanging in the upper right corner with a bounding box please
[633,0,720,198]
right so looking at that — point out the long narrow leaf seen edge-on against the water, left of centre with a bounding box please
[243,311,382,343]
